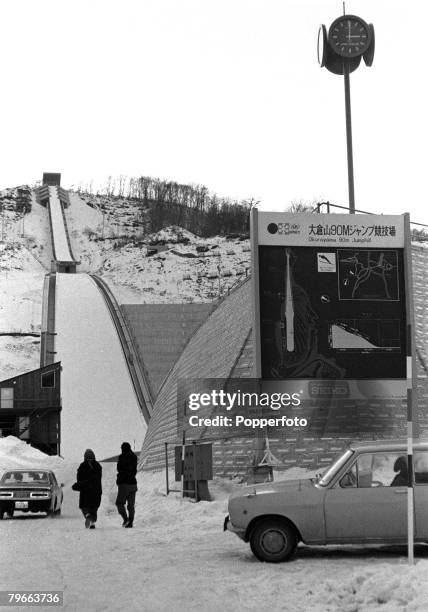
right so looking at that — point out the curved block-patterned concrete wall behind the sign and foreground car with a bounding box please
[139,245,428,475]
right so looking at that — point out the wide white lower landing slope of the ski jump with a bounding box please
[55,273,146,461]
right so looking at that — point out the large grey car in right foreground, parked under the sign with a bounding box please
[224,442,428,563]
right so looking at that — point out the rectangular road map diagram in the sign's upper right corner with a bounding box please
[338,249,399,302]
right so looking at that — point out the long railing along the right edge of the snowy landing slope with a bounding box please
[89,274,154,423]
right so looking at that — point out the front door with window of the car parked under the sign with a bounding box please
[324,451,407,542]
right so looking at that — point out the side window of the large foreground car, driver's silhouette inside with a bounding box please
[357,451,407,488]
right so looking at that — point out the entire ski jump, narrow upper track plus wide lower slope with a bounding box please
[41,186,151,461]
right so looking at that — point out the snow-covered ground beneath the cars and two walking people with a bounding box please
[0,438,428,612]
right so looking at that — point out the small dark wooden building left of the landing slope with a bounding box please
[0,362,61,455]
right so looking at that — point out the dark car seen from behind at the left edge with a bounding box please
[0,469,64,520]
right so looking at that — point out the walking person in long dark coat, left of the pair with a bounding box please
[77,448,102,529]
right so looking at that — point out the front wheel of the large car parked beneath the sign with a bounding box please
[250,518,298,563]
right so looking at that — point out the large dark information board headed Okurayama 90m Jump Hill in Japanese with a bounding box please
[252,210,407,396]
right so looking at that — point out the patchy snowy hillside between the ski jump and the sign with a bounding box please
[65,193,250,304]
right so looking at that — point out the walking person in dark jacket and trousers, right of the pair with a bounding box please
[116,442,137,529]
